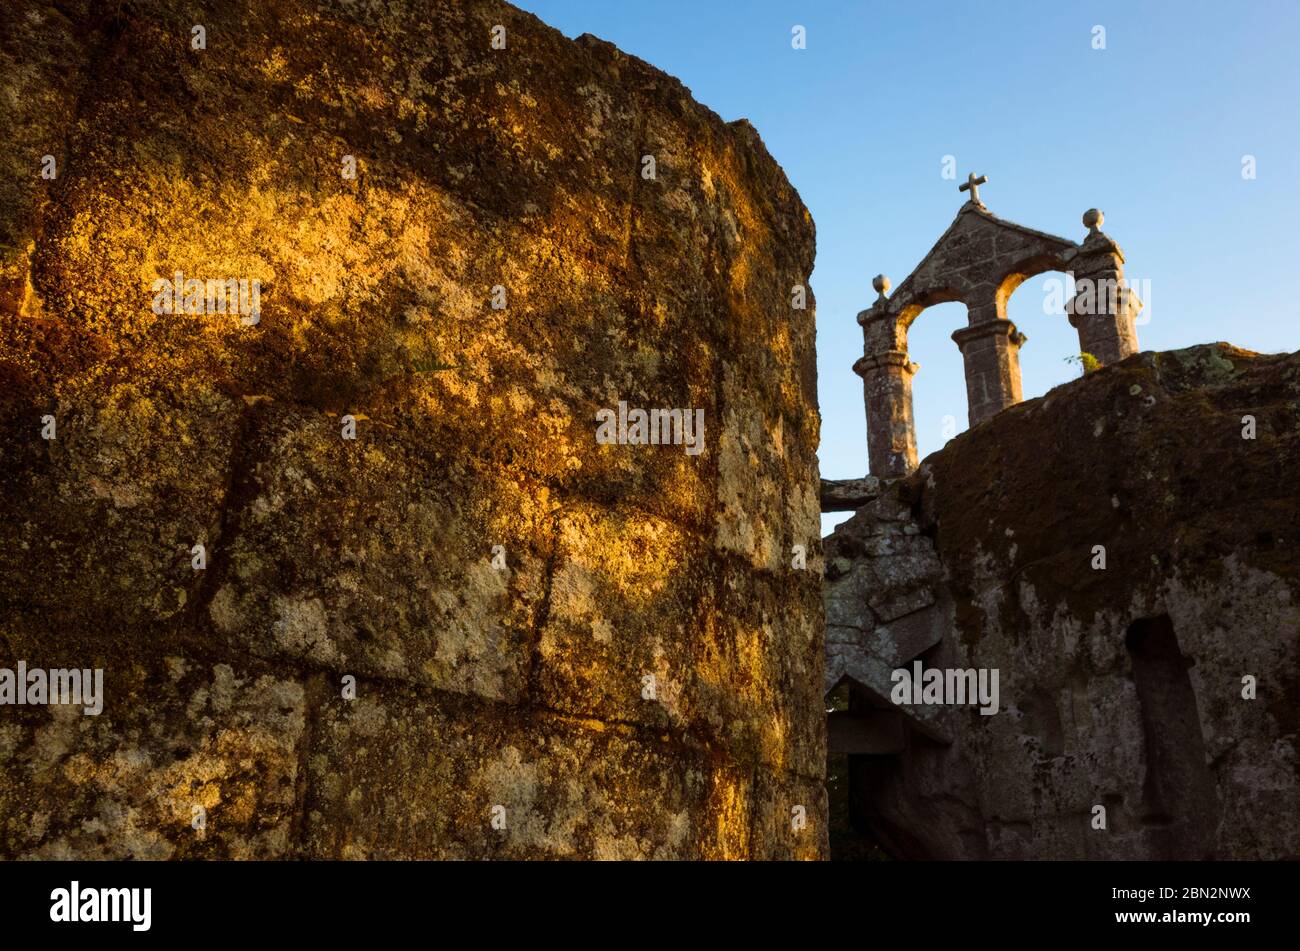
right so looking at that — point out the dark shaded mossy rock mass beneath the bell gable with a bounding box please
[826,344,1300,859]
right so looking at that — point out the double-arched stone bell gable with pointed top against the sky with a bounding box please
[853,193,1140,478]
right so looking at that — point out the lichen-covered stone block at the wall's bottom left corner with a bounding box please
[0,653,309,859]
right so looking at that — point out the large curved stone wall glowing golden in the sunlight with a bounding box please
[0,0,826,857]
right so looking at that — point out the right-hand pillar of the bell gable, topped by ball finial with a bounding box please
[1066,208,1141,364]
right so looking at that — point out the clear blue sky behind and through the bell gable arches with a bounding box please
[516,0,1300,530]
